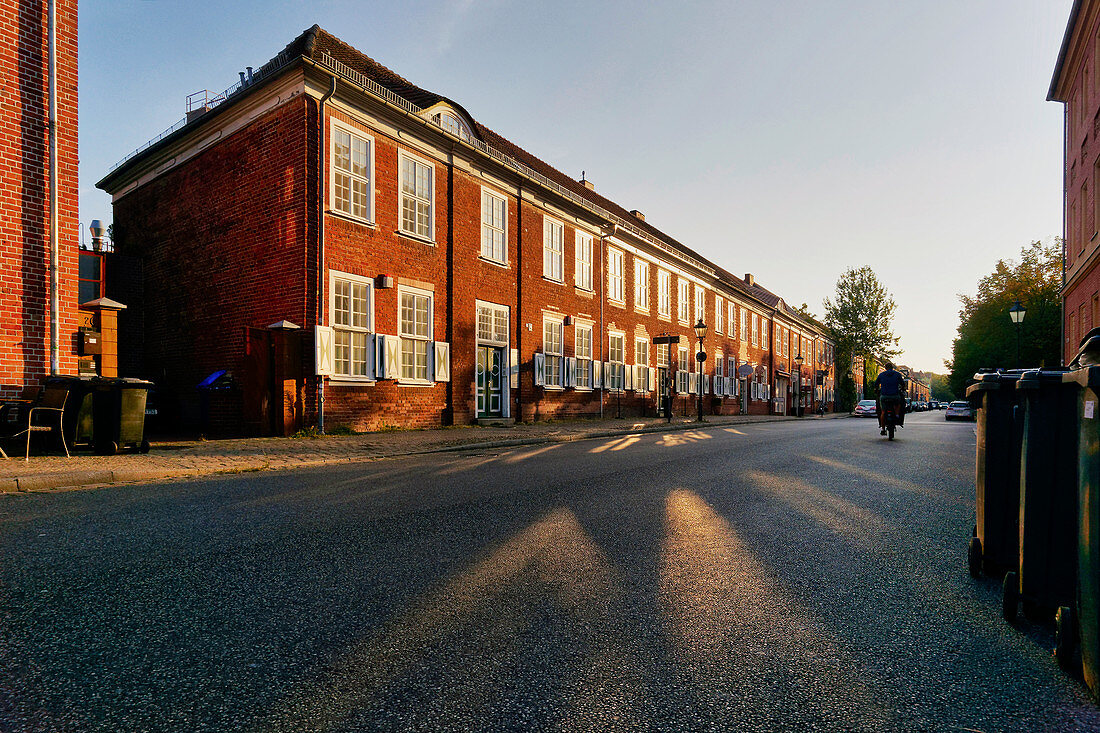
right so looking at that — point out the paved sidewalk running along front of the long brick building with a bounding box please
[0,413,848,493]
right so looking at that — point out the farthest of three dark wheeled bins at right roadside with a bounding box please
[966,371,1022,578]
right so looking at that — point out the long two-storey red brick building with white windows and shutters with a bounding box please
[98,26,834,434]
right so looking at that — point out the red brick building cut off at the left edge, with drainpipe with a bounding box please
[0,0,79,397]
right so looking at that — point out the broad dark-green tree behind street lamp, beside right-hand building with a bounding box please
[944,239,1062,395]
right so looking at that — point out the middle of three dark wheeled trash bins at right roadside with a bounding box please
[1002,370,1078,622]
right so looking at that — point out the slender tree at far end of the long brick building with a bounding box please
[824,266,899,409]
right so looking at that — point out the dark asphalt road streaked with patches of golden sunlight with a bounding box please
[0,413,1100,732]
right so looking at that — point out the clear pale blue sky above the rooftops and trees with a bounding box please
[80,0,1071,372]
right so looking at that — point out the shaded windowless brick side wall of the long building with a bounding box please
[114,98,312,430]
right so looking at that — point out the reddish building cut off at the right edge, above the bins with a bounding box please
[1047,0,1100,363]
